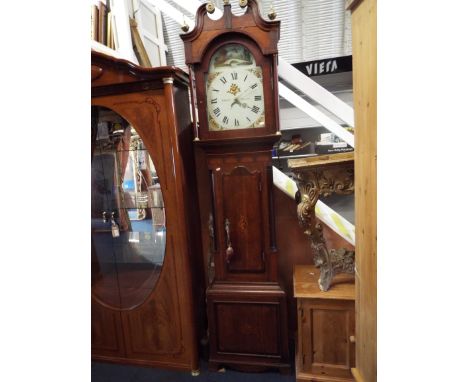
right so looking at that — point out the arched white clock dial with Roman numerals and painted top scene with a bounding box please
[206,44,265,131]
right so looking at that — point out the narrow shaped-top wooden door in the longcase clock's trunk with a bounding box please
[215,166,266,280]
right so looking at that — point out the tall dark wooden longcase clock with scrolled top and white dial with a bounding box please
[181,0,290,370]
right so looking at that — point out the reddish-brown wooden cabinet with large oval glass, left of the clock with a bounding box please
[91,52,203,371]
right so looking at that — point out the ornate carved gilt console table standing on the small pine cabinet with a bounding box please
[290,155,354,291]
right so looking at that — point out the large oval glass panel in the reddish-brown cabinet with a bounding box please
[91,106,166,309]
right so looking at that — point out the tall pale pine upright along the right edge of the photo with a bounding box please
[346,0,377,382]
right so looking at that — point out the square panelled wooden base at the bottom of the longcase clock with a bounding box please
[206,283,291,373]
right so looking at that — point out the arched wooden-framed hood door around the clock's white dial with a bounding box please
[193,35,277,142]
